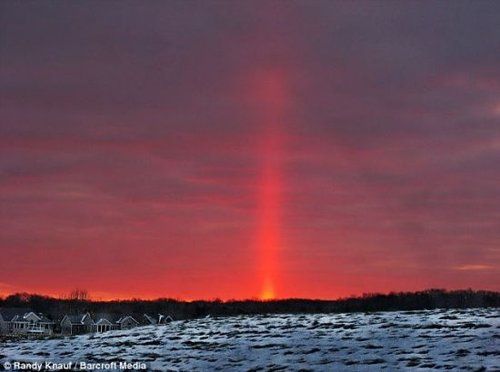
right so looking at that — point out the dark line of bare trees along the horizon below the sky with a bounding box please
[0,289,500,320]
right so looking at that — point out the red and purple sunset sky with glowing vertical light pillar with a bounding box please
[0,0,500,300]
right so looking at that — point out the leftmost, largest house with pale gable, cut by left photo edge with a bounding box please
[0,308,54,335]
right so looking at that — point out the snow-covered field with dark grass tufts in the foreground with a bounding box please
[0,309,500,371]
